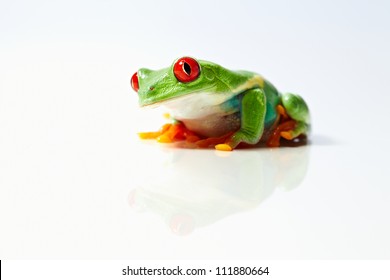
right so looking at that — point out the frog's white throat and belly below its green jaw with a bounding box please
[164,93,240,137]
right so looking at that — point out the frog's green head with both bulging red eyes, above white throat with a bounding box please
[130,57,222,106]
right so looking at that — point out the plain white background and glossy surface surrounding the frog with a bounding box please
[0,0,390,259]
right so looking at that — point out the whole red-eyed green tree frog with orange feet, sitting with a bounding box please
[130,56,310,151]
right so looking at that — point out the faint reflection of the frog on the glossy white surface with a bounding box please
[129,146,310,235]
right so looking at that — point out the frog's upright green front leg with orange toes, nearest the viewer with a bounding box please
[215,88,266,151]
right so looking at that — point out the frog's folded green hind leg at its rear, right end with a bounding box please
[280,93,310,140]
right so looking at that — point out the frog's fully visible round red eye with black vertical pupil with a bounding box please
[173,57,200,83]
